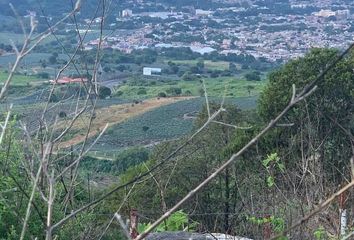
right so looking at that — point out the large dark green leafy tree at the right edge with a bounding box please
[258,49,354,191]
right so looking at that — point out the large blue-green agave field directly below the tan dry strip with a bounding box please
[87,97,256,157]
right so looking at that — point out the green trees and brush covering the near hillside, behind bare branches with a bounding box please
[1,49,354,239]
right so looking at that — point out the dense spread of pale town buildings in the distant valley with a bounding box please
[85,0,354,61]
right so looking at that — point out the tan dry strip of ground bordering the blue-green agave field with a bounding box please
[58,97,193,149]
